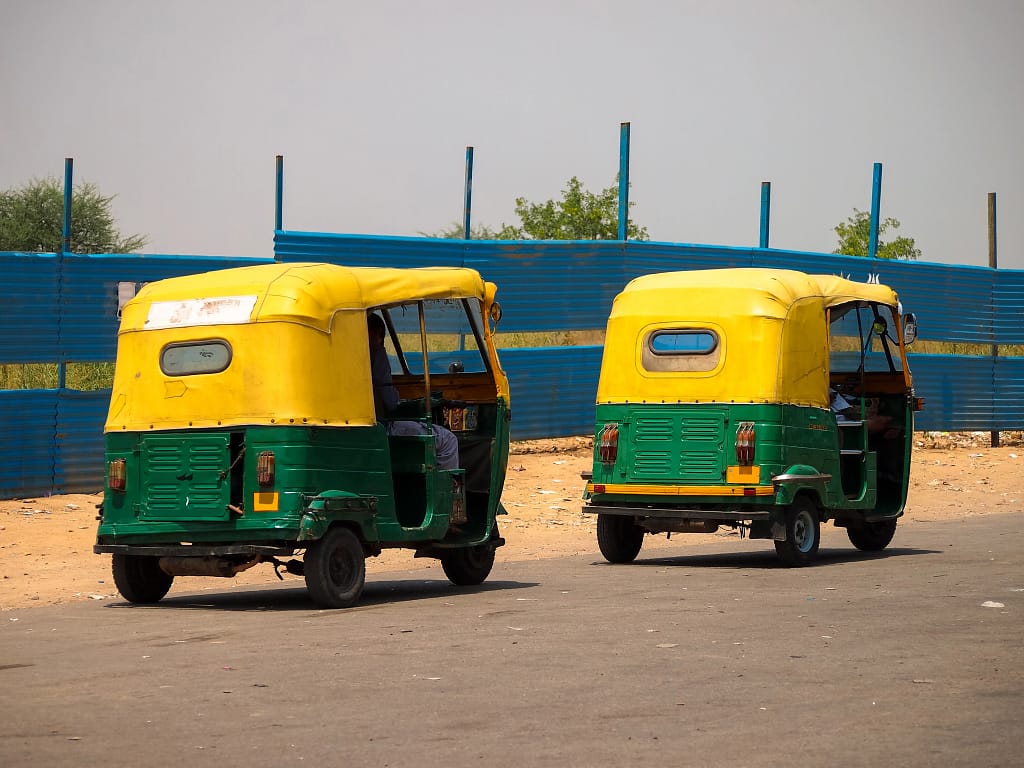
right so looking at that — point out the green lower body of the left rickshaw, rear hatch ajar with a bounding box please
[97,401,509,547]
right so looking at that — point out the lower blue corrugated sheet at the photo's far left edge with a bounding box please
[0,389,57,499]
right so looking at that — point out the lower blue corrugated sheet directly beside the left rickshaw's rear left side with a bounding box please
[53,389,111,494]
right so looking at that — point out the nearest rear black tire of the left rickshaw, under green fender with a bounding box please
[303,526,367,608]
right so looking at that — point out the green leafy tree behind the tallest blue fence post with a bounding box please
[499,176,649,240]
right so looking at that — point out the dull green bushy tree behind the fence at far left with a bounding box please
[0,177,148,253]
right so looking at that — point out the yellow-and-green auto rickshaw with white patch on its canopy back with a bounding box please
[93,263,510,607]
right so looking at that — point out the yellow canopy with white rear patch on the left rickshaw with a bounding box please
[105,263,508,432]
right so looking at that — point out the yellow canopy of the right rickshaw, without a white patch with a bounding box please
[597,268,898,408]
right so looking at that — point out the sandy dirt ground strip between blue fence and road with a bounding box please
[0,432,1024,611]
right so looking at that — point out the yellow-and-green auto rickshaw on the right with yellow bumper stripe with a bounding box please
[583,268,922,565]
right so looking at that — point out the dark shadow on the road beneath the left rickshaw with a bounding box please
[104,577,538,612]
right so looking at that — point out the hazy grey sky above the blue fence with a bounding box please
[0,0,1024,268]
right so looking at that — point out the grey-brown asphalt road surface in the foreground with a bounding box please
[0,514,1024,768]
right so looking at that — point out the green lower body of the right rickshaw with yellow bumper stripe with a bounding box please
[590,403,910,519]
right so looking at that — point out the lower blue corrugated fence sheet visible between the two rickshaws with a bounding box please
[499,346,602,440]
